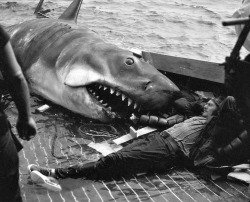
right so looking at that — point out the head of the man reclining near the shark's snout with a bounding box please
[202,97,223,118]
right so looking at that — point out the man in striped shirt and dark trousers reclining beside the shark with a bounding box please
[28,94,250,180]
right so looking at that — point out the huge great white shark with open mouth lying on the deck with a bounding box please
[8,0,179,122]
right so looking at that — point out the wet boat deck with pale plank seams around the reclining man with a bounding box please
[3,97,250,202]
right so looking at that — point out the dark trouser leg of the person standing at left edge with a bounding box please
[0,119,22,202]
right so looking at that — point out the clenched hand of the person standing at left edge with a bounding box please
[16,117,36,140]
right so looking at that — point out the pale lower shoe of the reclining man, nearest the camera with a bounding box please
[30,170,62,192]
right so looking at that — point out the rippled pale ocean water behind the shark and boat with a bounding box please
[0,0,246,63]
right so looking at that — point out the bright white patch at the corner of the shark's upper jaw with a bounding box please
[64,67,100,87]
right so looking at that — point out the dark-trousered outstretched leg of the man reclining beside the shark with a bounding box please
[35,134,178,179]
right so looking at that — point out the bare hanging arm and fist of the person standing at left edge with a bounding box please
[0,41,36,140]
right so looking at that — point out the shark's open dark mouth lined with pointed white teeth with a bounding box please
[87,84,142,118]
